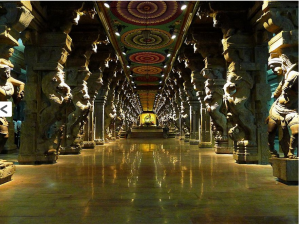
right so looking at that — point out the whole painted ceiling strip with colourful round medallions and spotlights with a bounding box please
[97,1,194,111]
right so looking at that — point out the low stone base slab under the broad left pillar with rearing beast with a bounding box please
[18,154,58,165]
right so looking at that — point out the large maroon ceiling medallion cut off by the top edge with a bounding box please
[110,1,182,26]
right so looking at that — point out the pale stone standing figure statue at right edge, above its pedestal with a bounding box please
[266,53,299,159]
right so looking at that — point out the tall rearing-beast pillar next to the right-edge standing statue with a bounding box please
[209,2,263,162]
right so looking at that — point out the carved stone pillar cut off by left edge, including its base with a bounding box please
[0,2,33,185]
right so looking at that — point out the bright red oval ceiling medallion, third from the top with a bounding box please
[129,52,165,64]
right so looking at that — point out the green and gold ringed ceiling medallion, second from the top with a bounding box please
[121,28,173,50]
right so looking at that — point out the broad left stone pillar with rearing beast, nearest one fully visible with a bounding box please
[18,2,85,164]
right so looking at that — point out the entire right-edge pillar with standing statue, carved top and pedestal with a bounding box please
[257,1,299,181]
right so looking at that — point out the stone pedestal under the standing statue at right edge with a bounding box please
[269,158,299,182]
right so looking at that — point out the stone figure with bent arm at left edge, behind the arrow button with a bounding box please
[0,64,25,152]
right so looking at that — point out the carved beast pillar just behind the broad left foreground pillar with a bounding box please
[60,30,100,154]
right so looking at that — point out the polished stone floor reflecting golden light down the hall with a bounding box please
[0,139,299,224]
